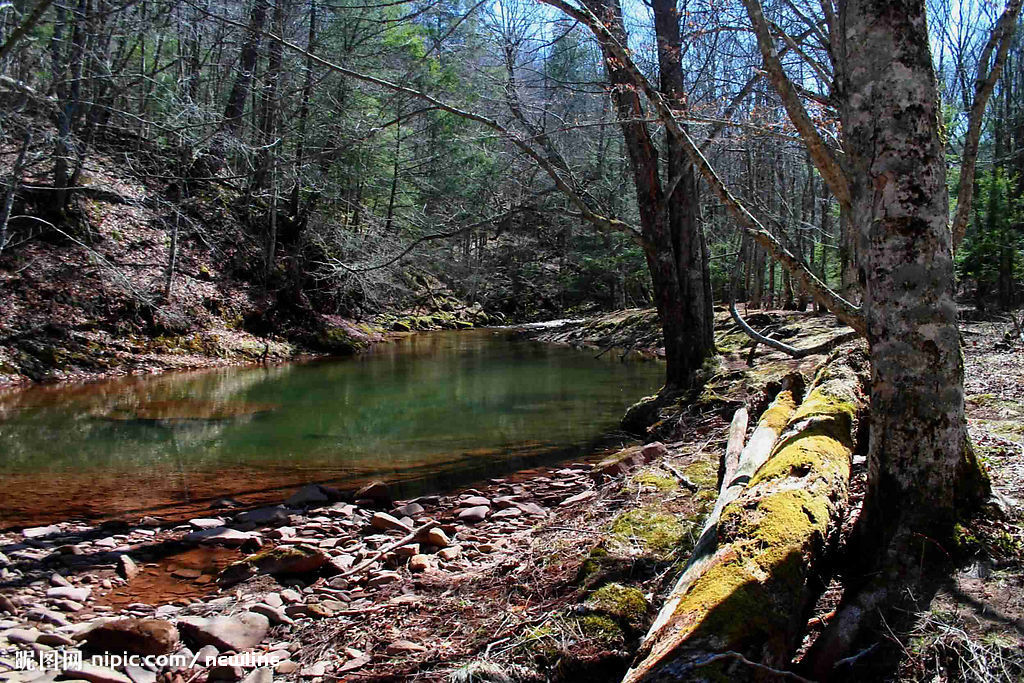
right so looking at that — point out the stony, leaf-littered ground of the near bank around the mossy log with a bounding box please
[0,311,1024,683]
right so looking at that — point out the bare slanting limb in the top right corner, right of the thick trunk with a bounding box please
[952,0,1024,250]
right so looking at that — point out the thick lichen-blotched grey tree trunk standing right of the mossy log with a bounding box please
[812,0,987,678]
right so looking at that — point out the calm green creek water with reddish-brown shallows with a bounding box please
[0,330,664,527]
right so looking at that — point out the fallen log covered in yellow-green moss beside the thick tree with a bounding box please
[625,354,864,683]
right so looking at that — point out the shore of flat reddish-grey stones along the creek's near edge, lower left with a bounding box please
[0,443,712,683]
